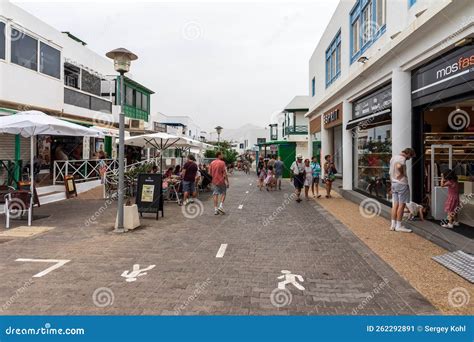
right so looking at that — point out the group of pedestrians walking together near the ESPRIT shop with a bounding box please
[290,154,337,203]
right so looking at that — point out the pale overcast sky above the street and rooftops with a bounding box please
[15,0,337,130]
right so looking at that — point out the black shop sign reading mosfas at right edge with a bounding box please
[411,45,474,106]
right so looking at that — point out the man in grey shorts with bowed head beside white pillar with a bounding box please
[389,147,416,233]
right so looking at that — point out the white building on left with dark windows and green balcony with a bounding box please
[0,1,153,183]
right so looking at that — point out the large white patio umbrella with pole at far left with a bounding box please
[0,110,102,225]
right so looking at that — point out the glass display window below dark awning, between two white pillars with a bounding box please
[354,124,392,201]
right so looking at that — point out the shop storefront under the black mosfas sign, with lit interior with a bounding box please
[412,45,474,226]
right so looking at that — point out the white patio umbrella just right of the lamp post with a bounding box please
[125,132,192,173]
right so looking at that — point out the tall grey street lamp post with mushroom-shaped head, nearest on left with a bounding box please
[105,48,138,233]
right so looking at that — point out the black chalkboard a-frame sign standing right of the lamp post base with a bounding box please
[135,173,164,220]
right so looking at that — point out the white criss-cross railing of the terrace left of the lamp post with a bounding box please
[53,159,118,185]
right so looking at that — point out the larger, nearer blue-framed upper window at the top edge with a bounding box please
[349,0,387,64]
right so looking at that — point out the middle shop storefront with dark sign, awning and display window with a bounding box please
[345,85,392,202]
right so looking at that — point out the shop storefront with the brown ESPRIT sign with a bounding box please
[322,103,343,176]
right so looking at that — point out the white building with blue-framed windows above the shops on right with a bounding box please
[306,0,474,228]
